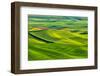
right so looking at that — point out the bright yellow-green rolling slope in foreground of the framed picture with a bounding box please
[29,29,87,60]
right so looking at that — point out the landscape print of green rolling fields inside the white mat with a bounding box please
[28,15,88,61]
